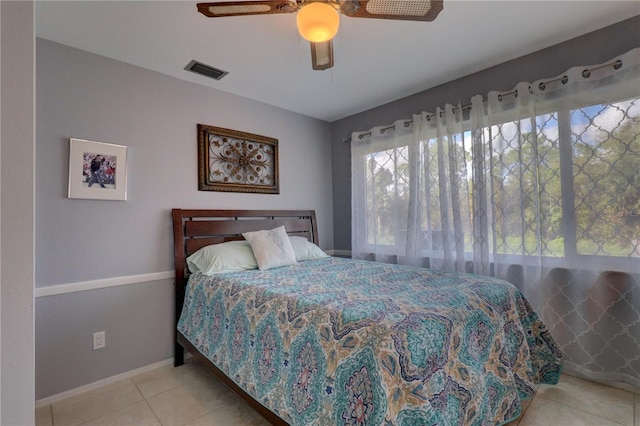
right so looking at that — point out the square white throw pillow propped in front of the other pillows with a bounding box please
[242,226,296,271]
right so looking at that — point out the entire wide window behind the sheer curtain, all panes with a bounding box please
[363,98,640,270]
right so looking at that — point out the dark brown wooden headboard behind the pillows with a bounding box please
[171,209,318,292]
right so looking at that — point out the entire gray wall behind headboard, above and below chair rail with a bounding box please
[35,39,333,398]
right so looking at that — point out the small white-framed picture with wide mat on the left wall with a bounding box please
[69,138,127,200]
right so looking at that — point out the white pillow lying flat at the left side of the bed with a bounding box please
[187,241,258,275]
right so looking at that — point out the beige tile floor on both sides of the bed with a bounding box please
[36,362,640,426]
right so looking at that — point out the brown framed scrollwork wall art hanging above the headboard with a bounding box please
[198,124,280,194]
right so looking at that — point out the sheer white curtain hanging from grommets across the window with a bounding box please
[351,49,640,387]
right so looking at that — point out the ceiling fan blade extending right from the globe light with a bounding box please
[340,0,444,21]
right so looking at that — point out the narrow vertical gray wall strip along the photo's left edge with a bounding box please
[0,1,35,425]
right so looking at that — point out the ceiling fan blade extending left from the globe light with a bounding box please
[198,0,298,18]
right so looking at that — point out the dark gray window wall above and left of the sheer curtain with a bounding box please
[331,16,640,250]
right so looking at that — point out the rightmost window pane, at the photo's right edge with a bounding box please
[569,98,640,257]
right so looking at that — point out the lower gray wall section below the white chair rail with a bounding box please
[35,280,174,399]
